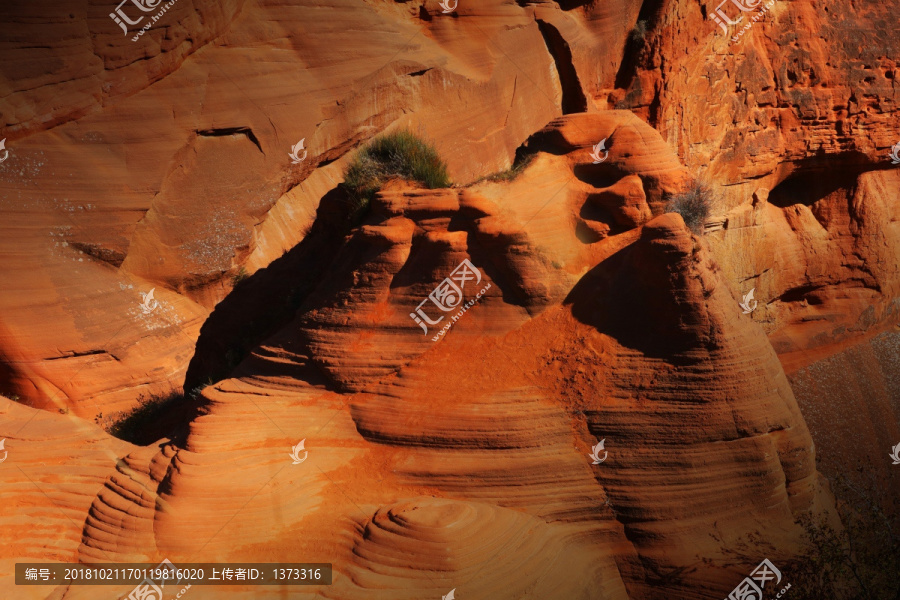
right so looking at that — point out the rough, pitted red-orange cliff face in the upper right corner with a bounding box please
[616,0,900,208]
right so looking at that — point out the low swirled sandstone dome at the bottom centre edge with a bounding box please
[325,498,625,600]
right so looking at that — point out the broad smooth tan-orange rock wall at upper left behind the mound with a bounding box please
[0,0,622,416]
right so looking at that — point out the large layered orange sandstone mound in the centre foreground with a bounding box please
[0,112,830,598]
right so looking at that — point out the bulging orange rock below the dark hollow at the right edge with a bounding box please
[708,169,900,369]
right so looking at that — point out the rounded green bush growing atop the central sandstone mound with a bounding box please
[343,130,450,213]
